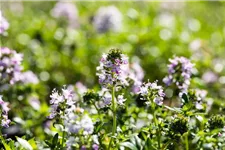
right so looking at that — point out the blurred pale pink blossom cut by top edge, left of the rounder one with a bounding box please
[51,1,79,28]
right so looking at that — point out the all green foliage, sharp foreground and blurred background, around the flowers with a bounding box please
[0,0,225,150]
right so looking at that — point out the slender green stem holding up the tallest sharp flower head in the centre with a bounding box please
[108,86,116,150]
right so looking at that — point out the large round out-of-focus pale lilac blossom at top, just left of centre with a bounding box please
[93,6,122,33]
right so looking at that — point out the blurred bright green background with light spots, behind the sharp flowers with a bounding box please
[1,0,225,101]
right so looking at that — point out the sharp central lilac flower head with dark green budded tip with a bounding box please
[97,49,128,87]
